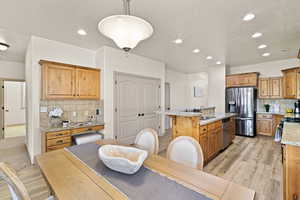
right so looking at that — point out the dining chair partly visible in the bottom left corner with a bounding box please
[0,162,55,200]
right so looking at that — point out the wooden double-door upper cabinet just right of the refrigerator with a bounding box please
[258,77,282,99]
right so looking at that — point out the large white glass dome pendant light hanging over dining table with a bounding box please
[98,0,153,52]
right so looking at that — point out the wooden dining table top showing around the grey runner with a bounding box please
[37,140,255,200]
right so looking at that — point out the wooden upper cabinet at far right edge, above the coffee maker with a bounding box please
[282,68,300,99]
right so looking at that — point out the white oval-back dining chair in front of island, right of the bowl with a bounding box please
[167,136,204,170]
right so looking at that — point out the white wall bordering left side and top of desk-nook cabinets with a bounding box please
[26,36,96,162]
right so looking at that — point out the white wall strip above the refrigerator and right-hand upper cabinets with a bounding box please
[227,58,300,77]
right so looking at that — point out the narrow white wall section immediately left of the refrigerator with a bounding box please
[207,65,226,113]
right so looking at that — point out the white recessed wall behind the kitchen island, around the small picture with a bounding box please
[166,69,208,110]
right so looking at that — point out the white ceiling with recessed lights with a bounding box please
[0,0,300,73]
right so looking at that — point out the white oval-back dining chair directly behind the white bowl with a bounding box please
[134,128,159,154]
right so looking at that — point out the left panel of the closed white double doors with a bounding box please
[116,74,140,144]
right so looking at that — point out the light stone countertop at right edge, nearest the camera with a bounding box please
[281,122,300,146]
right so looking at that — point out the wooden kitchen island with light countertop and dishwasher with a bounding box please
[162,111,235,164]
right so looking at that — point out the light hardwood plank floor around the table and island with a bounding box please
[0,134,282,200]
